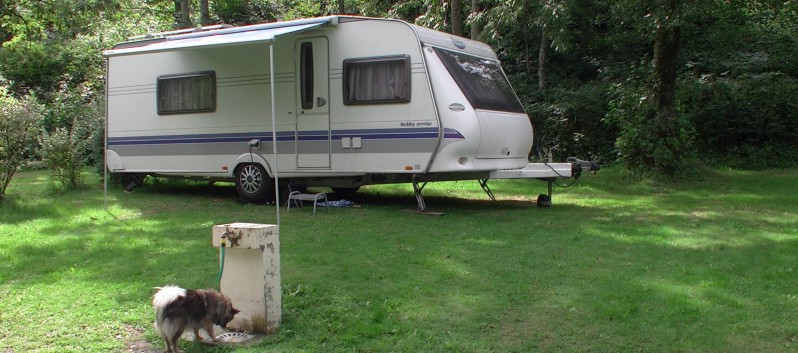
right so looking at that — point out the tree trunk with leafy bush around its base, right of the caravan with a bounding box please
[614,0,704,177]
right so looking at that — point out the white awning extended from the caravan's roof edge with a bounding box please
[103,17,336,57]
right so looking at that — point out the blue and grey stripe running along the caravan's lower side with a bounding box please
[108,128,465,145]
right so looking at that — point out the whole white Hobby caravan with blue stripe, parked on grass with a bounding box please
[104,16,595,211]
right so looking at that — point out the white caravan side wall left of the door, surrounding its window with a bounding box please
[108,45,293,176]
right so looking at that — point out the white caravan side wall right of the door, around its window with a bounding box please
[322,19,442,173]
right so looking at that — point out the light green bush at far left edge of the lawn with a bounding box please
[0,86,43,199]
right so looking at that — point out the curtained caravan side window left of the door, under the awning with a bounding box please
[158,71,216,115]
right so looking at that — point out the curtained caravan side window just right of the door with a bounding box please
[343,55,410,105]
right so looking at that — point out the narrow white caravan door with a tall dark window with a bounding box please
[295,37,330,168]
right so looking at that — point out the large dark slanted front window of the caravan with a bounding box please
[435,48,524,113]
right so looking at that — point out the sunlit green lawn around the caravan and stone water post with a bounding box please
[0,169,798,352]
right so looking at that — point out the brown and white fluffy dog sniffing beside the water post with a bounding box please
[152,286,239,353]
